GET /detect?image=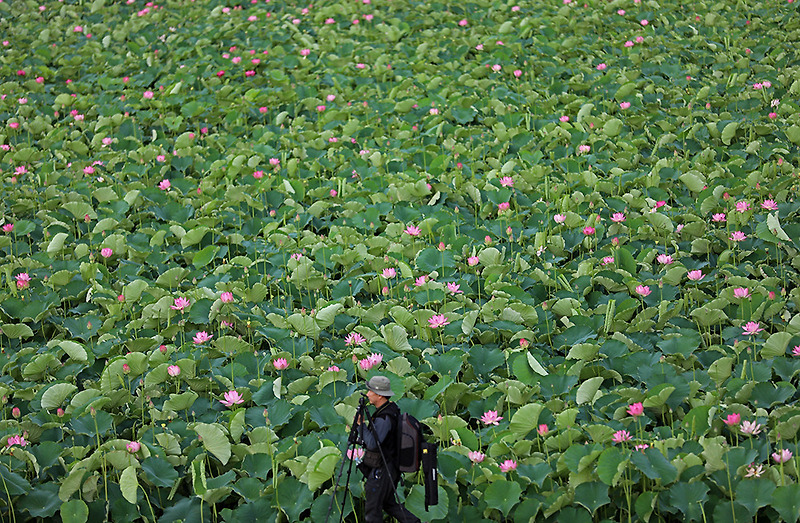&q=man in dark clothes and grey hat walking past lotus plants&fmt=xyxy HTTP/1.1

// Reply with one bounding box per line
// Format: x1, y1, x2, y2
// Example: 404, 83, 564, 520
356, 376, 419, 523
